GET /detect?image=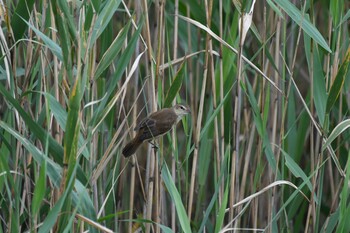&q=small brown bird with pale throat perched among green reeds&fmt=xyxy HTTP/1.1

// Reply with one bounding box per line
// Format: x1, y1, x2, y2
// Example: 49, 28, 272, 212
122, 104, 191, 157
